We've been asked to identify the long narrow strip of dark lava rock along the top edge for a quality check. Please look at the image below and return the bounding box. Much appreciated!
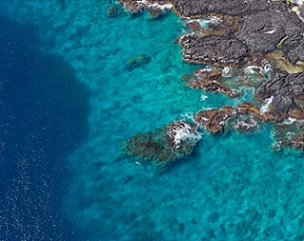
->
[170,0,269,17]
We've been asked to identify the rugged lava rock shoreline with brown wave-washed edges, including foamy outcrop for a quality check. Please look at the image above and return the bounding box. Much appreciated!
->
[120,0,304,166]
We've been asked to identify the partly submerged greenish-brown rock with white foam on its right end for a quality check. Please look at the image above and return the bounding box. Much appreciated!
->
[124,121,201,167]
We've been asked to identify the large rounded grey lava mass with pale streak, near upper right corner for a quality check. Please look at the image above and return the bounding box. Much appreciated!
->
[236,7,304,61]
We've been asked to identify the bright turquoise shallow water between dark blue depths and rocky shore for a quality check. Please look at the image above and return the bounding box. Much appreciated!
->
[0,0,304,241]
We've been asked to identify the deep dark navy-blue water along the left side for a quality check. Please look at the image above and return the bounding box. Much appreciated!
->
[0,16,90,240]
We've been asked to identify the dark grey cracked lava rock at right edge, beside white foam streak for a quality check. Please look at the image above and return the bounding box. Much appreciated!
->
[256,71,304,120]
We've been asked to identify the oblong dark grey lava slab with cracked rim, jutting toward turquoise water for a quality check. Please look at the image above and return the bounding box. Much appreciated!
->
[179,35,248,65]
